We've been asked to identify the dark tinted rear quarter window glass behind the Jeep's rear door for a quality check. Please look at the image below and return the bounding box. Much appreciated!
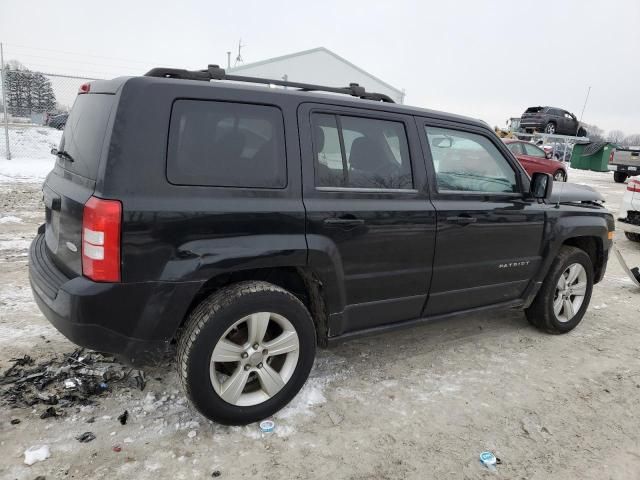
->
[167,100,287,188]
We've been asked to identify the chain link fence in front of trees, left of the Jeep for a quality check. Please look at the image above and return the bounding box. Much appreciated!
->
[0,62,102,161]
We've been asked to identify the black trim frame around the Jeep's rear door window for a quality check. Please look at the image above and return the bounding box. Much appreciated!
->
[309,108,419,194]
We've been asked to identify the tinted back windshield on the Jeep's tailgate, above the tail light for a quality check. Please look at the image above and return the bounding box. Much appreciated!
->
[58,93,115,180]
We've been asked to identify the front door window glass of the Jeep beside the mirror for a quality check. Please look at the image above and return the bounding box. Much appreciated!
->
[425,127,518,193]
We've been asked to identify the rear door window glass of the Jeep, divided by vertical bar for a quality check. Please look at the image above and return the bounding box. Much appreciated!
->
[311,113,413,189]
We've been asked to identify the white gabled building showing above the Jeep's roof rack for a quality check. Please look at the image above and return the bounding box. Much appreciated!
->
[227,47,405,103]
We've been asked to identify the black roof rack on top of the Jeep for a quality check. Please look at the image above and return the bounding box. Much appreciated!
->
[144,65,395,103]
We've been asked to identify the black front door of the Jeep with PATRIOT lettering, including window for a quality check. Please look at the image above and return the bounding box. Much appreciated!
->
[419,119,544,316]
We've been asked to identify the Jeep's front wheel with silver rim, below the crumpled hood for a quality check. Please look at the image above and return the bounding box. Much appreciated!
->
[525,245,593,334]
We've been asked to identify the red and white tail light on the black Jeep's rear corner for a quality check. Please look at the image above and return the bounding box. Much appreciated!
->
[82,197,122,282]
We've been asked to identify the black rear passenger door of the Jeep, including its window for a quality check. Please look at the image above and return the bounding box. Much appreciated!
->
[298,104,436,336]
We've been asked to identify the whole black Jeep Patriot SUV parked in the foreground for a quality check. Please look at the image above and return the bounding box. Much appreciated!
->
[30,66,614,424]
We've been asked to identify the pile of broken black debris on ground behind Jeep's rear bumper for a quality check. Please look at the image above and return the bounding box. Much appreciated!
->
[0,348,146,416]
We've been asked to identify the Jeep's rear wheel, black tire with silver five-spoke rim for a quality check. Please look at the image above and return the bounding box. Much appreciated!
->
[177,281,316,425]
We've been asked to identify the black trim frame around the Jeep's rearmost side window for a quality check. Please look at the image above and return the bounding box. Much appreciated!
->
[164,97,289,191]
